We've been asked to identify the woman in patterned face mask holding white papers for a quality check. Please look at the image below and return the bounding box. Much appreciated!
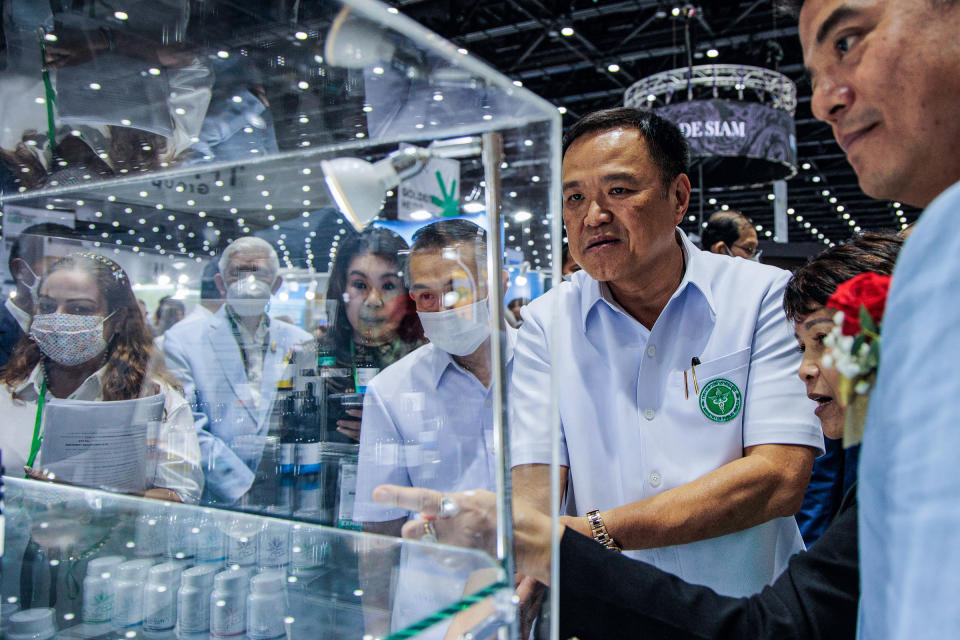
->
[0,253,203,503]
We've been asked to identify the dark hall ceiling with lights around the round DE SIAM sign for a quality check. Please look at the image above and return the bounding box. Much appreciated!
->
[393,0,918,242]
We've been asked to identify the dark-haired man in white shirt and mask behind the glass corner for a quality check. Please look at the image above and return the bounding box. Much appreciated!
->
[353,220,516,635]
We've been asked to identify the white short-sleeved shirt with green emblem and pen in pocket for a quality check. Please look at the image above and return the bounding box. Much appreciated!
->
[510,231,823,596]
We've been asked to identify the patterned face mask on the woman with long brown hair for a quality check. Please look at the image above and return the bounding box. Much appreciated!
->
[30,312,116,367]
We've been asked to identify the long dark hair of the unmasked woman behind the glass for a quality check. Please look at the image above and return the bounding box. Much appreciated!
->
[327,228,423,358]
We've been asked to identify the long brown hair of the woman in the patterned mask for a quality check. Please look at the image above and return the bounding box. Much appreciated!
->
[0,253,177,400]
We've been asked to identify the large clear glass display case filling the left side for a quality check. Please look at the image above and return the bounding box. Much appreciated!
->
[0,0,561,638]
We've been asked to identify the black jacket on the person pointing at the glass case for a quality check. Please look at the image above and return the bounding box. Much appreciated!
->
[559,485,860,640]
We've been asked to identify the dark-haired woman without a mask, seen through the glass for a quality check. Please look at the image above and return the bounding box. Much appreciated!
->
[321,229,424,442]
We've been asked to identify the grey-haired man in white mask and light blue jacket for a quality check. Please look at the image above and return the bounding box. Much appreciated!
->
[163,236,310,504]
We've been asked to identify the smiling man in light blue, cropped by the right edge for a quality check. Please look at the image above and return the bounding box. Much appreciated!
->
[796,0,960,640]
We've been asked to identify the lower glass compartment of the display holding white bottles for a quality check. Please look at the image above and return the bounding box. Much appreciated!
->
[0,478,510,640]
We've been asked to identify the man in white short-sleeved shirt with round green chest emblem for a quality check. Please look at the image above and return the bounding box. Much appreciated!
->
[510,109,823,595]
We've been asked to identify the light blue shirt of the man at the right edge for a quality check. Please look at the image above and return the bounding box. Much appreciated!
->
[859,183,960,640]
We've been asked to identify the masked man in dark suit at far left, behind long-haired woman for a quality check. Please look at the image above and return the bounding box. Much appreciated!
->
[0,223,81,367]
